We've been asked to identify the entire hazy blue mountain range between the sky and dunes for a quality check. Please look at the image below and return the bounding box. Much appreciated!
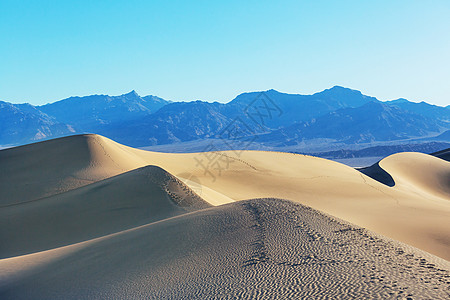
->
[0,86,450,149]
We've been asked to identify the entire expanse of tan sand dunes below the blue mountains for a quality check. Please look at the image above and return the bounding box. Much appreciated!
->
[0,135,450,299]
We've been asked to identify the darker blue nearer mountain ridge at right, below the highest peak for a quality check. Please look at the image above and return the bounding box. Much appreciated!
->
[256,102,446,144]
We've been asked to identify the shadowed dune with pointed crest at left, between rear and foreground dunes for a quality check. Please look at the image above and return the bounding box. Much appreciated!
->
[0,166,209,258]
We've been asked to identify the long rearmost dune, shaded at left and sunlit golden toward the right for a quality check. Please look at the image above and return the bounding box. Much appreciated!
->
[0,135,450,259]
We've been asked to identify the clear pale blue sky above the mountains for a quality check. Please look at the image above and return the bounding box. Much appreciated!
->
[0,0,450,105]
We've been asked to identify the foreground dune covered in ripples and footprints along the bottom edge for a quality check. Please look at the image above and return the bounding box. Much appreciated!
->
[0,199,450,299]
